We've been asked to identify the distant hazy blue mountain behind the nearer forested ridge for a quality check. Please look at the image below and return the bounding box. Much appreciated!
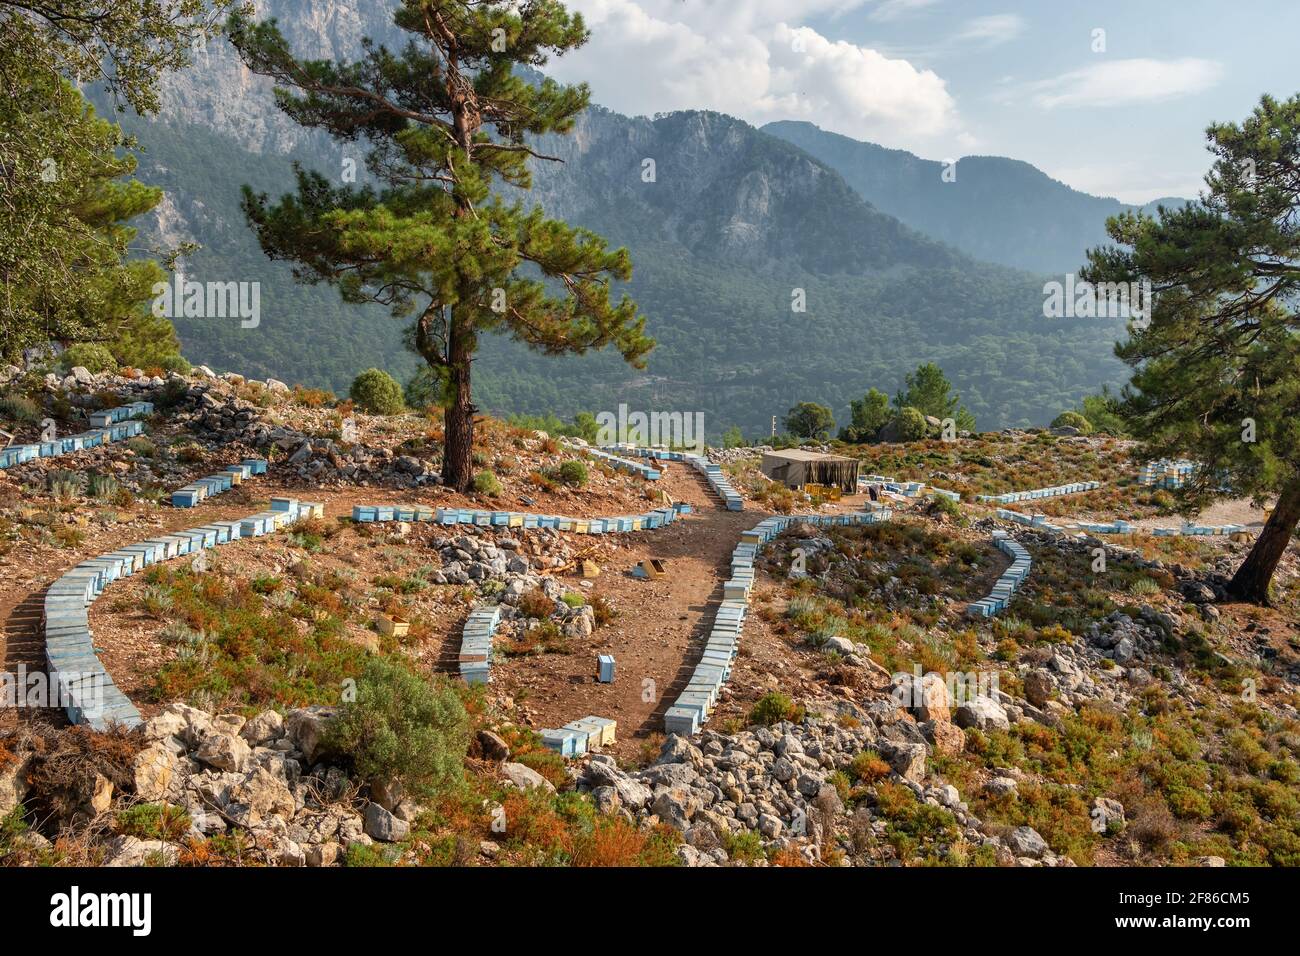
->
[762,121,1190,274]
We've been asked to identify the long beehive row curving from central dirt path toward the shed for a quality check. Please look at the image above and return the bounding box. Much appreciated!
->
[663,510,891,735]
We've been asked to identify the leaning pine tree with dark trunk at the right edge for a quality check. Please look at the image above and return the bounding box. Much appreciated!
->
[1084,96,1300,604]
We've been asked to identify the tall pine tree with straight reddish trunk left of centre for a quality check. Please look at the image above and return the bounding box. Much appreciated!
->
[229,0,654,490]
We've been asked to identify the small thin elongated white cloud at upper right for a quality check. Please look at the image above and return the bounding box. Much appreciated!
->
[1027,57,1223,109]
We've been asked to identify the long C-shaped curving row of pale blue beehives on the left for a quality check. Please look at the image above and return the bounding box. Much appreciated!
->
[43,498,324,730]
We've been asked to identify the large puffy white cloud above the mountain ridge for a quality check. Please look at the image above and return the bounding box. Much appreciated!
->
[545,0,961,150]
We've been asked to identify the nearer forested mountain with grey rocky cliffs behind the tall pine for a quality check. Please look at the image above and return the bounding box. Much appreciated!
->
[104,0,1123,436]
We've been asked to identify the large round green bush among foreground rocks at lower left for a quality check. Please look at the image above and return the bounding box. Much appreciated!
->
[324,657,469,797]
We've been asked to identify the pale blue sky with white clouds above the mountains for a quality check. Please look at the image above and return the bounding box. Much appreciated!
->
[547,0,1300,202]
